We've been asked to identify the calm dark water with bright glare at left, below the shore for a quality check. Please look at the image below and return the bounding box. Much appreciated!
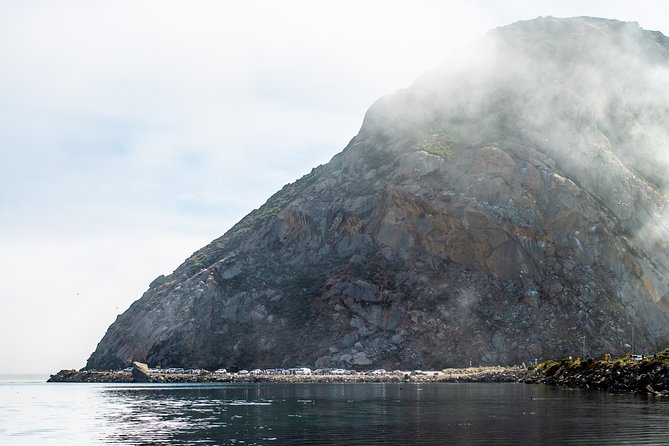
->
[0,381,669,446]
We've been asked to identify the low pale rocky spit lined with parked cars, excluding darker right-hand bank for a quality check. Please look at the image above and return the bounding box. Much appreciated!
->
[48,367,528,383]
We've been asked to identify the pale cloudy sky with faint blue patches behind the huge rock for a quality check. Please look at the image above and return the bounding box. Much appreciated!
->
[0,0,669,373]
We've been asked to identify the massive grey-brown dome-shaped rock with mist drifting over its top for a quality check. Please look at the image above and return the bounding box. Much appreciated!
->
[87,18,669,369]
